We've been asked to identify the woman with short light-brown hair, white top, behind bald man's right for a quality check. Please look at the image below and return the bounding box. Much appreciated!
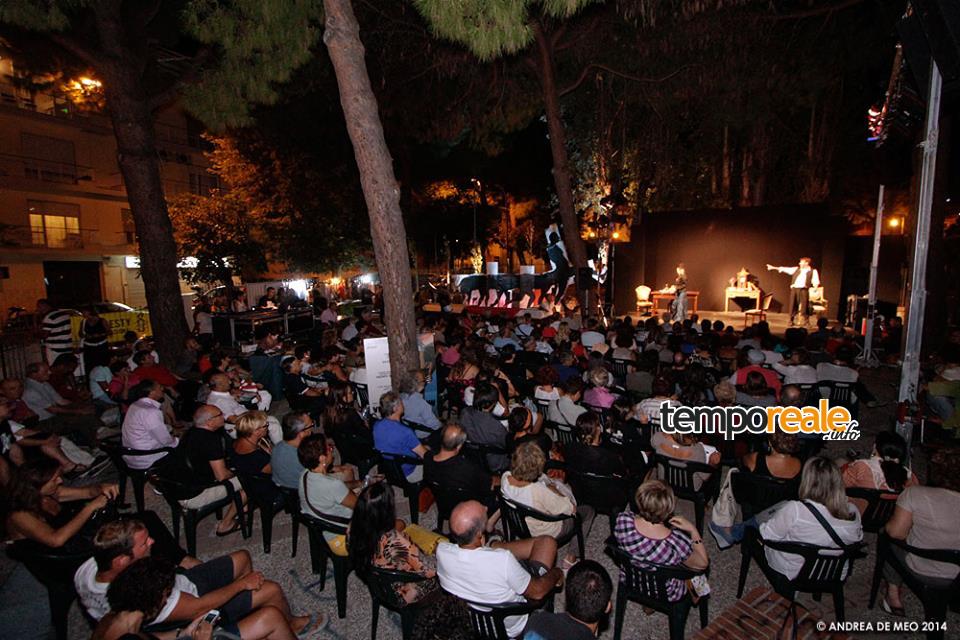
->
[500,442,594,538]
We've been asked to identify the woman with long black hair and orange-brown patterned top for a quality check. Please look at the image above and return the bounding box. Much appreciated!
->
[347,482,439,605]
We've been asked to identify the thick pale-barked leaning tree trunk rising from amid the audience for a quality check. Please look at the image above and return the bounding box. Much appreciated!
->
[323,0,420,382]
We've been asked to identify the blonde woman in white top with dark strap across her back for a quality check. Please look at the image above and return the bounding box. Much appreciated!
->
[757,456,863,580]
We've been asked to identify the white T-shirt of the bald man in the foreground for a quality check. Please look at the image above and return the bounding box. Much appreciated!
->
[437,542,532,638]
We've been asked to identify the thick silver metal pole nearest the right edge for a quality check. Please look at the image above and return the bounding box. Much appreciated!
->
[897,59,943,444]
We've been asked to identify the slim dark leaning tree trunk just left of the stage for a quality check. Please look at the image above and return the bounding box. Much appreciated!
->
[533,20,587,288]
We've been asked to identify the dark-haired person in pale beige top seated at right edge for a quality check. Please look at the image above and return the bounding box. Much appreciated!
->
[881,454,960,616]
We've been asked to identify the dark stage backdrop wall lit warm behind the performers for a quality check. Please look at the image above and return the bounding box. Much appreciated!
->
[614,205,847,318]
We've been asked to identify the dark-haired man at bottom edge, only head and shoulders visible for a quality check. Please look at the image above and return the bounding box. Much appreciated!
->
[523,560,613,640]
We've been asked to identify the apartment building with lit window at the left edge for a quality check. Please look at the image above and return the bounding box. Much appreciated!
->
[0,58,219,313]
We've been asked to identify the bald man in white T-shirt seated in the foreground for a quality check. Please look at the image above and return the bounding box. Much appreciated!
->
[437,500,563,638]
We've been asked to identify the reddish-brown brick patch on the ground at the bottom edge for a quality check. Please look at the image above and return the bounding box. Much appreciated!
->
[690,587,849,640]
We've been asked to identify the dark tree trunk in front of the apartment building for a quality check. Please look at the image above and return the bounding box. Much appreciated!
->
[96,7,190,364]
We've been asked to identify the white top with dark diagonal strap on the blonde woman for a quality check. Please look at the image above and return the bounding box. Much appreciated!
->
[760,500,863,580]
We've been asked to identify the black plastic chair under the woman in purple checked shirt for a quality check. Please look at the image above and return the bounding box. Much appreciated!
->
[607,540,710,640]
